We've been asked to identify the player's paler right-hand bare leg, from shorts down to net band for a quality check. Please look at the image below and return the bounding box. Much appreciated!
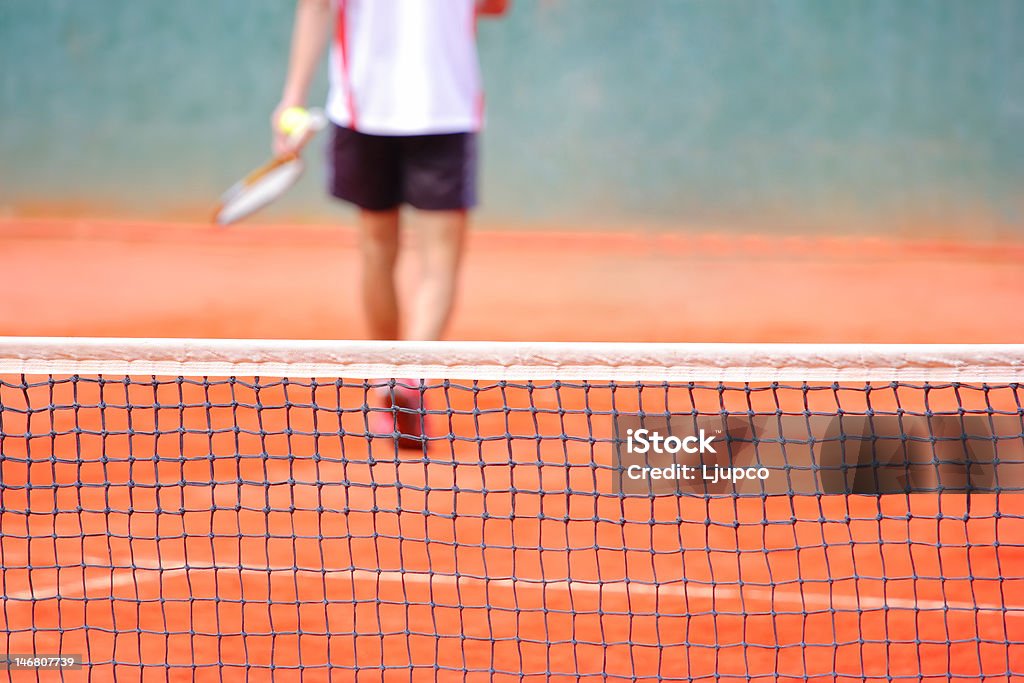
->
[408,211,469,340]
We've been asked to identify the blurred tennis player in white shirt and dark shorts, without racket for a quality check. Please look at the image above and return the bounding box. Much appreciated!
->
[272,0,508,445]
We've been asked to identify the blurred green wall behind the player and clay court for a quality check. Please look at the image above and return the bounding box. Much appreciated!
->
[0,0,1024,233]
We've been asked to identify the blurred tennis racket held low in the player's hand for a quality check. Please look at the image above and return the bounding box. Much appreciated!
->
[213,110,327,225]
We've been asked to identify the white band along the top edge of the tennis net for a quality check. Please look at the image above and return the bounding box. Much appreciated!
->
[0,337,1024,383]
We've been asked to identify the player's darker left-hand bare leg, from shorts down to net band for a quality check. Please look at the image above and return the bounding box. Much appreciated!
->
[359,209,398,339]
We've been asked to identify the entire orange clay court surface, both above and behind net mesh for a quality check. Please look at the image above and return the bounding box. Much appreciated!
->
[0,221,1024,682]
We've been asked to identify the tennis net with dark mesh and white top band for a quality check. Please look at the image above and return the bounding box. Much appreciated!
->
[0,338,1024,681]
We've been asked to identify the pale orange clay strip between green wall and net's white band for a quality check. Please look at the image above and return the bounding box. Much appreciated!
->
[6,219,1024,343]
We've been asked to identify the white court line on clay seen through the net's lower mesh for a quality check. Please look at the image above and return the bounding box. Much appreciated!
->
[6,557,1024,617]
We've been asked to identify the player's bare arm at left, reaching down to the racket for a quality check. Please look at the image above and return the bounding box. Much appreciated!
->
[270,0,333,154]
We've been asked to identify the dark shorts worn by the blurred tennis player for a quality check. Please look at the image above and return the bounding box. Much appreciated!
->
[328,125,476,211]
